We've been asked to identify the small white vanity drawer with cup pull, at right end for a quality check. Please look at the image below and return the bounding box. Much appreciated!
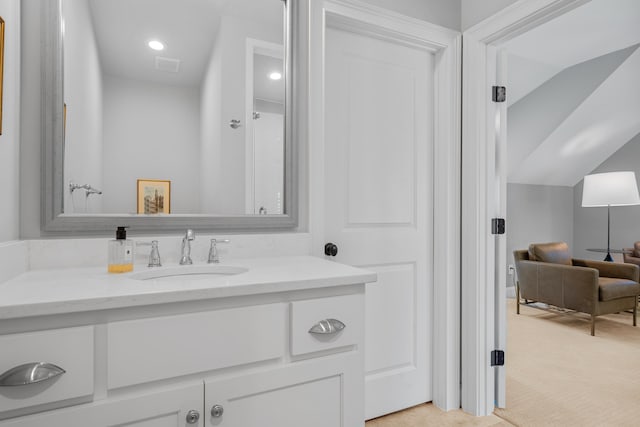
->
[291,295,364,356]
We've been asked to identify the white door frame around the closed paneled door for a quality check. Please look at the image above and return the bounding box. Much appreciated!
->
[306,0,462,411]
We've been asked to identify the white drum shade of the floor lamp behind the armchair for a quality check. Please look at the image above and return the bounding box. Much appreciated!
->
[582,172,640,207]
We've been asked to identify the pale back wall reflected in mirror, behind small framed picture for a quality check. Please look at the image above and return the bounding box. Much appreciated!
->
[102,75,201,214]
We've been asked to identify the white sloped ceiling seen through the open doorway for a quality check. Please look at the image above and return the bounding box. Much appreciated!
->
[505,0,640,186]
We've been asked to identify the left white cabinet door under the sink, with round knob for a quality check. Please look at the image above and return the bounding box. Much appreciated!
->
[0,383,204,427]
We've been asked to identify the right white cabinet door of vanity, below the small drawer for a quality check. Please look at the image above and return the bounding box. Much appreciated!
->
[204,353,364,427]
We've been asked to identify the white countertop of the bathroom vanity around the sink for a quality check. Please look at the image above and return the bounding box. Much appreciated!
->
[0,256,377,319]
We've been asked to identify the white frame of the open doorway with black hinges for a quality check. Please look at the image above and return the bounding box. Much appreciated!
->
[461,0,590,416]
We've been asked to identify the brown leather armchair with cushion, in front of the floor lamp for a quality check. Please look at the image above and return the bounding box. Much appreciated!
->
[513,242,640,335]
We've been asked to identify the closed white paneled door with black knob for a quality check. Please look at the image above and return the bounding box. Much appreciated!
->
[324,28,434,419]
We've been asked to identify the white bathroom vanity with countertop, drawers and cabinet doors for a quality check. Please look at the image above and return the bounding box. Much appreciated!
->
[0,256,376,427]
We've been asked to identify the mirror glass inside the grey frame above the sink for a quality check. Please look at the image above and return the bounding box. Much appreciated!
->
[62,0,285,216]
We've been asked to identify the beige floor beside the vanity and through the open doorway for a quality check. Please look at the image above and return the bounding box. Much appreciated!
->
[366,300,640,427]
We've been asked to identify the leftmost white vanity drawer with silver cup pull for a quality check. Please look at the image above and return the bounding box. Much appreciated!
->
[0,326,94,418]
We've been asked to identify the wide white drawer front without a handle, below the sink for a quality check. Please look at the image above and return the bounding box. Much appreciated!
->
[107,303,286,388]
